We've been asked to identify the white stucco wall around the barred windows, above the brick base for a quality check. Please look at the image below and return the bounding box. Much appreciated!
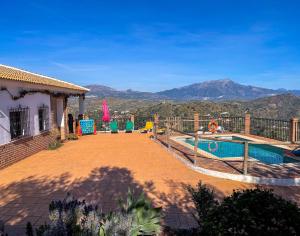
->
[0,83,51,145]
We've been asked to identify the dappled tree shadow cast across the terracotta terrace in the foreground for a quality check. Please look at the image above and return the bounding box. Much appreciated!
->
[0,166,222,235]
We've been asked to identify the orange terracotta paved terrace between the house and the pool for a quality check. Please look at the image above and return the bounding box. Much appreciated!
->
[0,133,300,235]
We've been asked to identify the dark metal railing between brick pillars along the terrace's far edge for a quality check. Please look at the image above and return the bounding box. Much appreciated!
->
[81,112,300,142]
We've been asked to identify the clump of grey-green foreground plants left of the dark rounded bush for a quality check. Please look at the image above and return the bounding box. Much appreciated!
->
[26,191,161,236]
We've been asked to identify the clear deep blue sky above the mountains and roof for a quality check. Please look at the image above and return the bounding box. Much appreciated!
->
[0,0,300,91]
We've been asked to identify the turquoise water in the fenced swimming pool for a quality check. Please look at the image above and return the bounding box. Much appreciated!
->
[185,136,297,164]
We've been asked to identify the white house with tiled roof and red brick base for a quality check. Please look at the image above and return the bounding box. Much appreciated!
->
[0,64,88,168]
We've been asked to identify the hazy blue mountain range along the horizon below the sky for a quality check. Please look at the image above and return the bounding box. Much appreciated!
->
[85,79,300,101]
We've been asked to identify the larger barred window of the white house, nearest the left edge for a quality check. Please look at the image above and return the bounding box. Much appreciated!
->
[9,106,30,139]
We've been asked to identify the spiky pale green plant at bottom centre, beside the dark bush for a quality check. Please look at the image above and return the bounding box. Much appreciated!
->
[100,190,161,236]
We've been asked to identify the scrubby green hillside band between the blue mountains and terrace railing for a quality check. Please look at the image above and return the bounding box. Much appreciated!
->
[69,94,300,120]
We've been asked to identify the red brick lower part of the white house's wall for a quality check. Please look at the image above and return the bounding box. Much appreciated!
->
[0,131,55,169]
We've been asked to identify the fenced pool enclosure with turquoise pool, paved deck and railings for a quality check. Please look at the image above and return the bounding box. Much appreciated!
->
[154,114,300,176]
